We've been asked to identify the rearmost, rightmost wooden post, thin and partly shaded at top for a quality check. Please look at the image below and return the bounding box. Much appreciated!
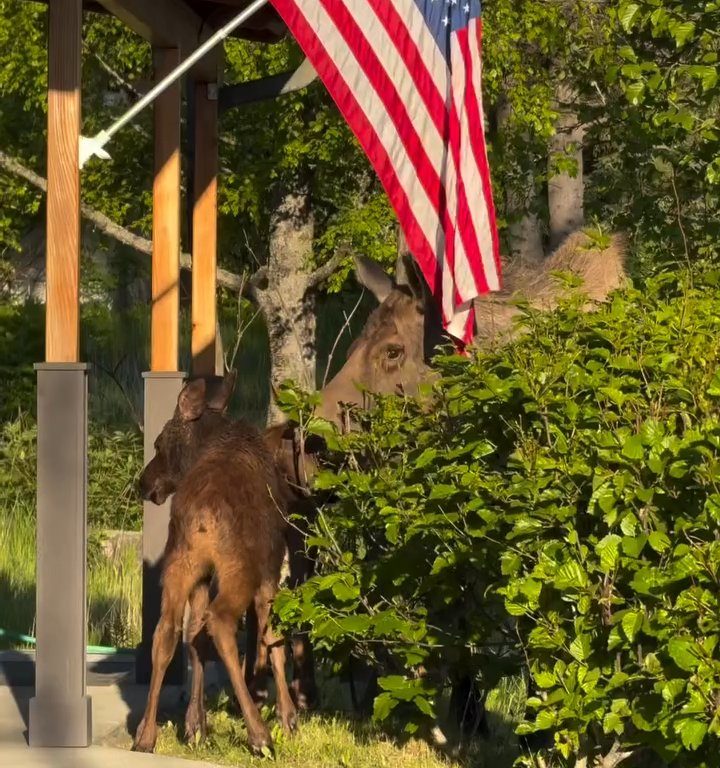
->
[192,83,218,376]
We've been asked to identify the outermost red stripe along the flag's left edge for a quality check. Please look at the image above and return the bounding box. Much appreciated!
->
[272,0,447,310]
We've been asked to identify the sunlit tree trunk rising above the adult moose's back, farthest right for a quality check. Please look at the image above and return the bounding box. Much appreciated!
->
[548,82,585,250]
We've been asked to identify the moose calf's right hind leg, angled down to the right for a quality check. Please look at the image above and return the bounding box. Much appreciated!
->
[205,571,272,754]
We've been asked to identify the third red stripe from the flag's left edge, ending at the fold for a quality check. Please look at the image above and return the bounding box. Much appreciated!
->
[367,0,449,137]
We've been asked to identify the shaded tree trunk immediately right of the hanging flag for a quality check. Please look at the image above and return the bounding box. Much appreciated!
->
[497,99,544,267]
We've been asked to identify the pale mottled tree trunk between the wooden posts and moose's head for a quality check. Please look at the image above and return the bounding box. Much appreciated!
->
[254,187,316,425]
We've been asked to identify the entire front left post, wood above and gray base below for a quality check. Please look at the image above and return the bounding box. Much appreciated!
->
[28,0,92,747]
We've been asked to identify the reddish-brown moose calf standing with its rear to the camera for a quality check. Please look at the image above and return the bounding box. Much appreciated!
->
[133,377,296,752]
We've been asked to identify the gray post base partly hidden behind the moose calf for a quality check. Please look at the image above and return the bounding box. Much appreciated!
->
[135,371,185,685]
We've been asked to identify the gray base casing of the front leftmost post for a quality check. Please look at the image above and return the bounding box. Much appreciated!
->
[29,363,92,747]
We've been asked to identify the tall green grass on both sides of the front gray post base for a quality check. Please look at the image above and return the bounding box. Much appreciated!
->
[0,501,142,648]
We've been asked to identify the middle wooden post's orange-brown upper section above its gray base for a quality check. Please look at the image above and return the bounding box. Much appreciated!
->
[150,48,180,371]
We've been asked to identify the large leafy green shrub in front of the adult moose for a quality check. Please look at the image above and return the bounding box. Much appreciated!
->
[276,275,720,766]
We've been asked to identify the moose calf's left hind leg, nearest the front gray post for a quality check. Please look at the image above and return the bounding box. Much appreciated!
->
[133,558,198,752]
